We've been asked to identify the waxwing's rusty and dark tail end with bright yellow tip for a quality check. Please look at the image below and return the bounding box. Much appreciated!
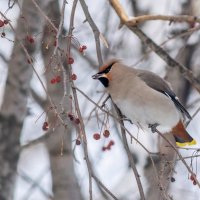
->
[172,121,196,147]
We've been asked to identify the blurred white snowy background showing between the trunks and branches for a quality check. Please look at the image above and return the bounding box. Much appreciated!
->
[0,0,200,200]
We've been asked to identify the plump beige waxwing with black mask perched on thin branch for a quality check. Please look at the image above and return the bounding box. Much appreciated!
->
[92,59,196,146]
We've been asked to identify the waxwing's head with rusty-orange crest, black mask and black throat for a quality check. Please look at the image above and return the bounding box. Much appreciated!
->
[92,59,120,87]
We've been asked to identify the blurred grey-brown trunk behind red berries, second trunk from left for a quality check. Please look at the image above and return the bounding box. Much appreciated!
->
[42,1,83,200]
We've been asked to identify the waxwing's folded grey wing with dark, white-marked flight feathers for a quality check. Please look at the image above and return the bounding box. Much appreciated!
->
[136,69,191,119]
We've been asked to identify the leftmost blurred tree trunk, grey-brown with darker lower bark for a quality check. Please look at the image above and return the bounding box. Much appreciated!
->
[0,0,52,200]
